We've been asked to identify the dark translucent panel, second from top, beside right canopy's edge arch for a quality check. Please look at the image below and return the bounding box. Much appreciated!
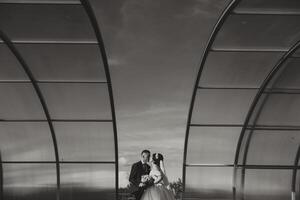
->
[213,15,300,50]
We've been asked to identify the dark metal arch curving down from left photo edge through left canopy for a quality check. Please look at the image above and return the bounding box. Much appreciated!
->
[0,30,60,200]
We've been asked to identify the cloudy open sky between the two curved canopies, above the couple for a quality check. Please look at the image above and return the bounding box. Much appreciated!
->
[92,0,228,187]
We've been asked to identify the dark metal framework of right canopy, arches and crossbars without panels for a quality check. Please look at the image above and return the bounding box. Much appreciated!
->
[183,0,300,199]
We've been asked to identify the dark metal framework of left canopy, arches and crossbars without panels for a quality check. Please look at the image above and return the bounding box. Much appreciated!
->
[0,0,119,200]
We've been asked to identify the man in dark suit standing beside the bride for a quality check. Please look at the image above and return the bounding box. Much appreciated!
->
[129,150,150,200]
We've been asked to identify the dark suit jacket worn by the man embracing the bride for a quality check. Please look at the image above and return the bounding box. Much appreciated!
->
[129,161,151,199]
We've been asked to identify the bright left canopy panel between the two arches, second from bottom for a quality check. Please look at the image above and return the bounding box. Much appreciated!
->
[54,122,115,161]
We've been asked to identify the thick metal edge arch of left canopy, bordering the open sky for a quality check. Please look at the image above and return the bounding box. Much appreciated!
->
[80,0,119,199]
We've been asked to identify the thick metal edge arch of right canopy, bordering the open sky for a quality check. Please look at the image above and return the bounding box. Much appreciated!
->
[182,0,240,192]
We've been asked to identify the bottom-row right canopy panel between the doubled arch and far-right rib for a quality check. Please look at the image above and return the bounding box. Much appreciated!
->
[244,169,292,200]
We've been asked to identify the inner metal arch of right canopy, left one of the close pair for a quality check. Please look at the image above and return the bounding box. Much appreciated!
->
[233,41,300,199]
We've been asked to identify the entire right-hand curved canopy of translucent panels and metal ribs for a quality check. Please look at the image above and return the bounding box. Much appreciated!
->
[183,0,300,200]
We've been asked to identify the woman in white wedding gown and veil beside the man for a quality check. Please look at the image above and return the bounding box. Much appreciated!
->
[141,153,175,200]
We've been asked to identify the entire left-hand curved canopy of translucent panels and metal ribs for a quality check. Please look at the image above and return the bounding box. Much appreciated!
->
[0,0,118,200]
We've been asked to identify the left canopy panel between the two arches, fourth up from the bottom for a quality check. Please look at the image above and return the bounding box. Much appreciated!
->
[16,44,106,81]
